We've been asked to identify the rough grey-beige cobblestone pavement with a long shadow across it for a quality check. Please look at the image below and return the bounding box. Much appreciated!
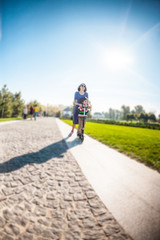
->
[0,118,131,240]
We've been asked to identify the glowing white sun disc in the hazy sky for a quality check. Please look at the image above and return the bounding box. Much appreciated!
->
[104,48,134,70]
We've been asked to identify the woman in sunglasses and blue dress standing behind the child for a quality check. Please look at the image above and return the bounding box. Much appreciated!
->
[69,83,88,137]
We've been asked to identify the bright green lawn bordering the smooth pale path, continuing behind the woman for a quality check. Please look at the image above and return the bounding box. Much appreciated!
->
[63,120,160,171]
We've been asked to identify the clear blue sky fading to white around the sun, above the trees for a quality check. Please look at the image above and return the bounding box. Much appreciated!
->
[0,0,160,114]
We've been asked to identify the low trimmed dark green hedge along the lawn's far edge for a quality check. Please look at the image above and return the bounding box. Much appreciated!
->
[87,118,160,130]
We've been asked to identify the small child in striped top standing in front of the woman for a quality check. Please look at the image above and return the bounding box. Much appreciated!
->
[77,97,90,136]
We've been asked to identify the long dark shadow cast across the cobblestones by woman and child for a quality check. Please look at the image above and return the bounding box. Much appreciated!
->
[0,137,81,173]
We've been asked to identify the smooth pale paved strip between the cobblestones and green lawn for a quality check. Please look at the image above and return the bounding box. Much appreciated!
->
[57,120,160,240]
